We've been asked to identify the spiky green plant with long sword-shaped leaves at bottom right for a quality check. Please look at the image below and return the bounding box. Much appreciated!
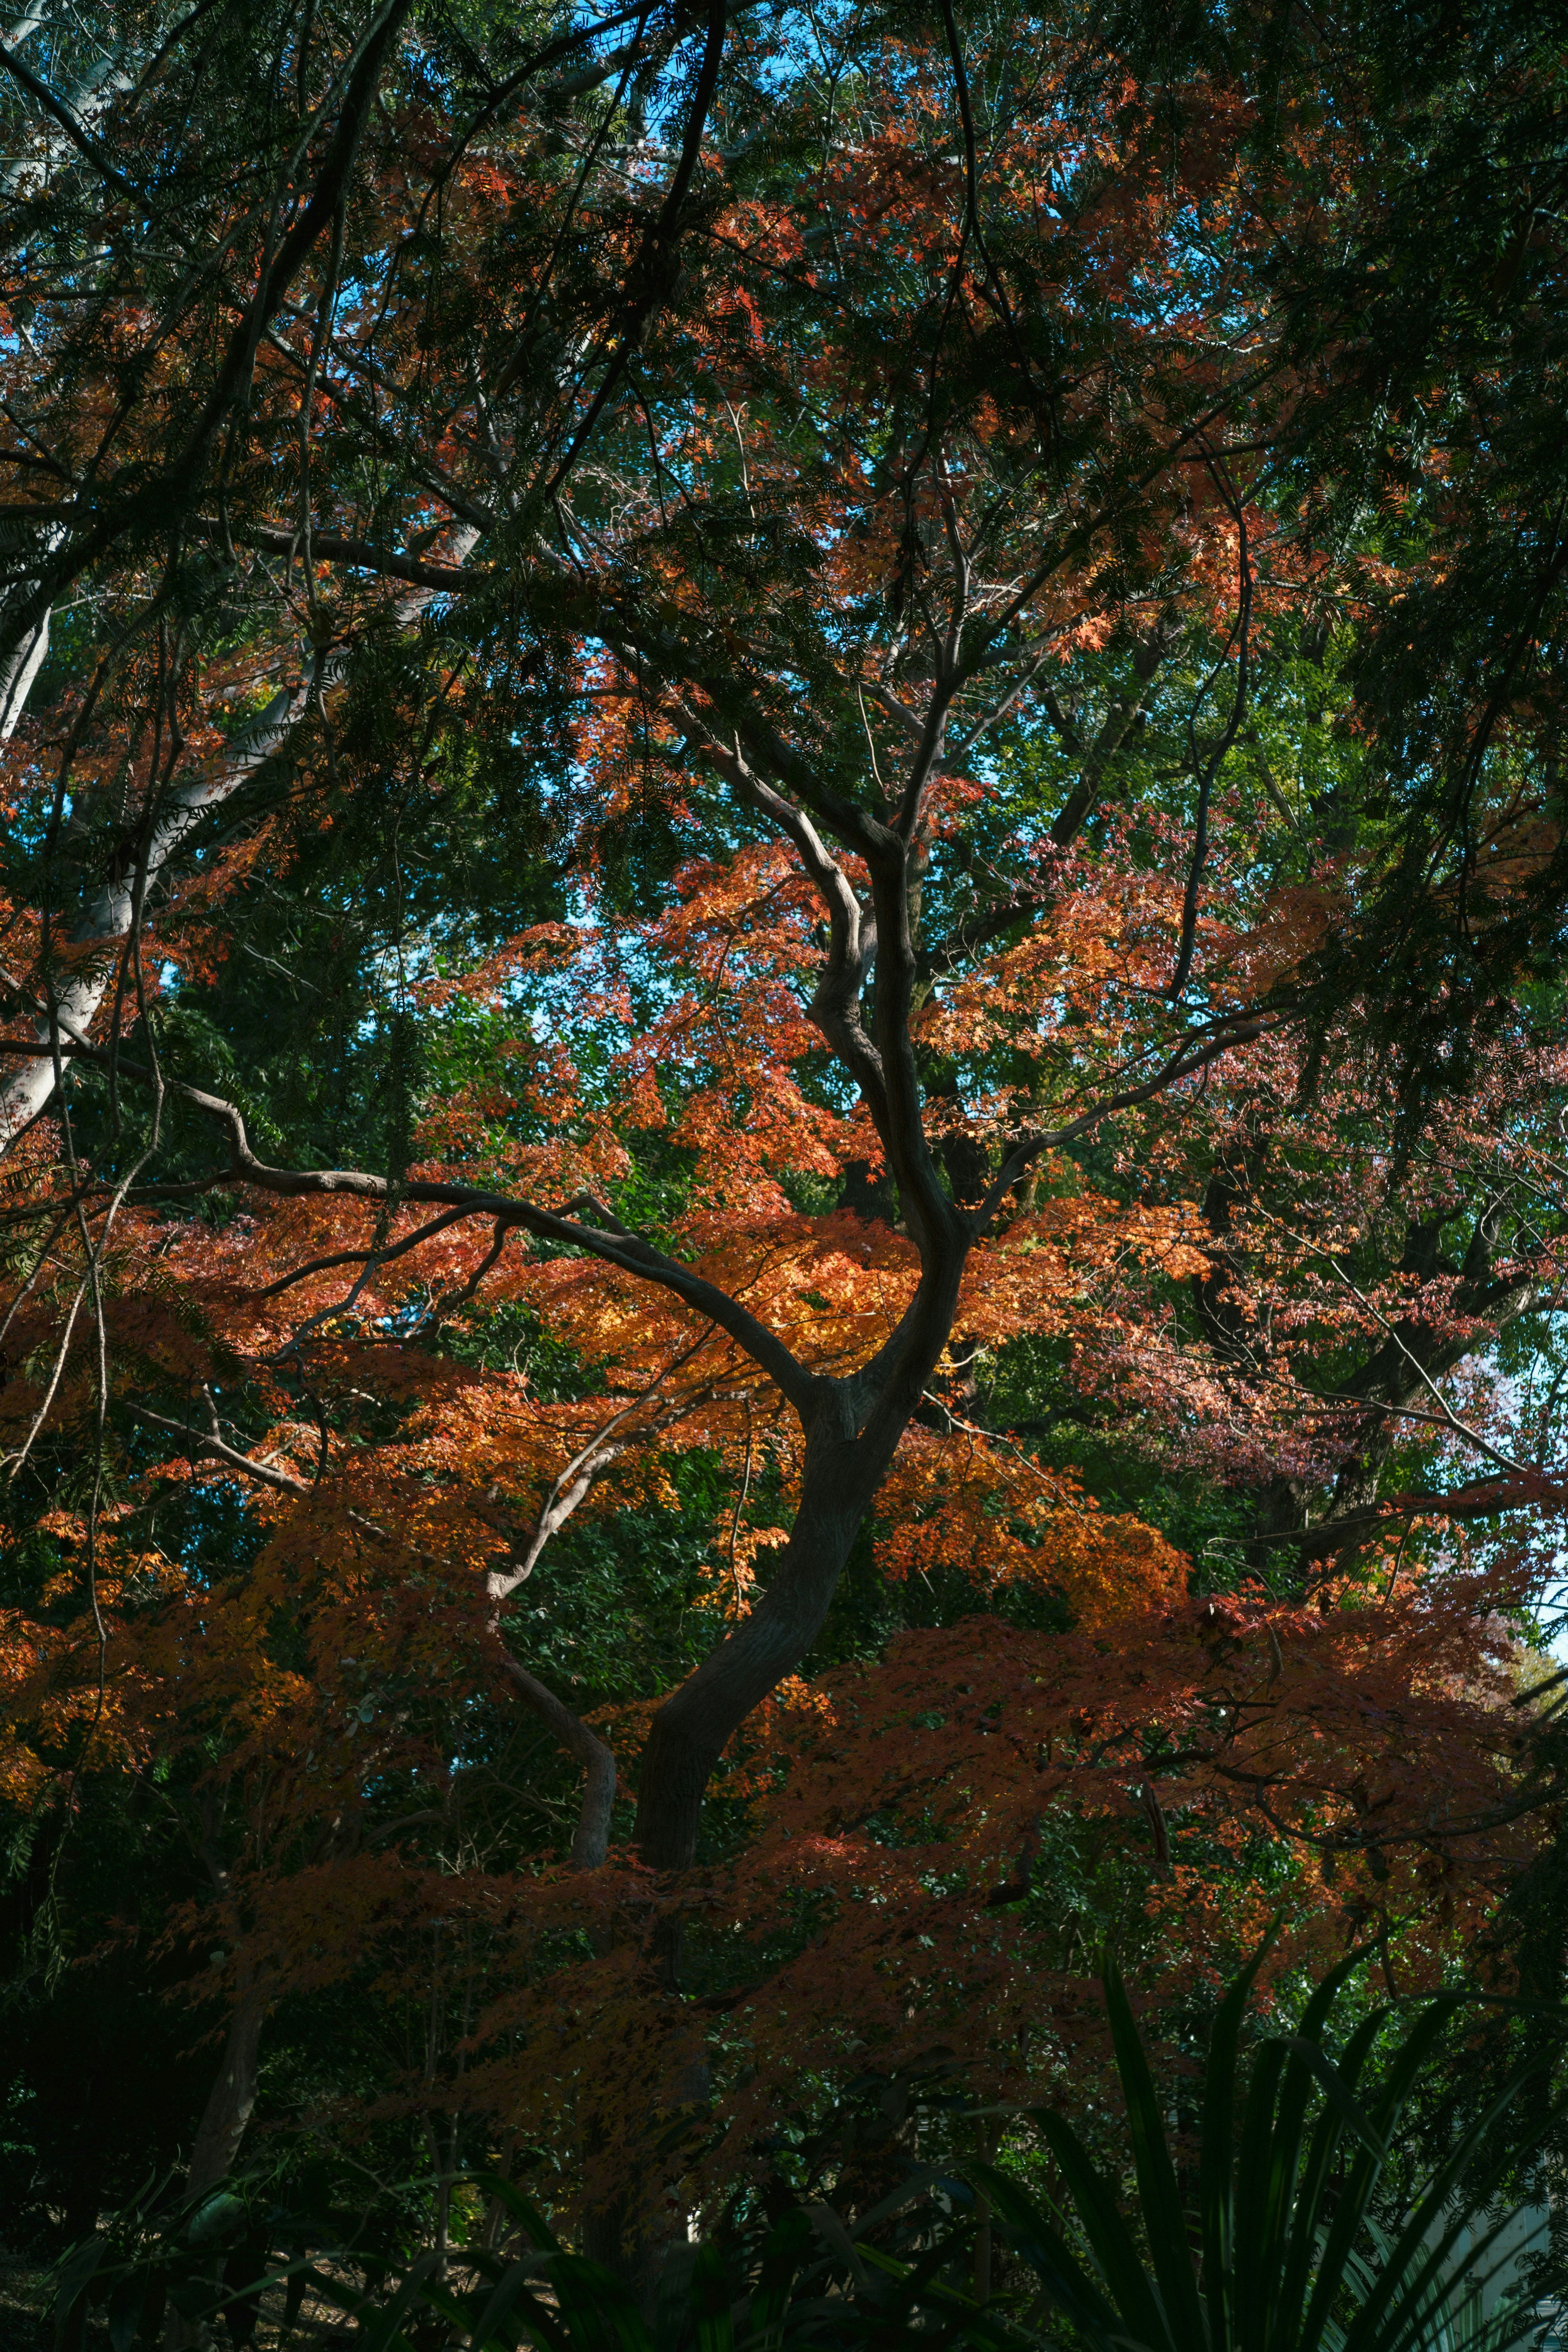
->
[959,1952,1568,2352]
